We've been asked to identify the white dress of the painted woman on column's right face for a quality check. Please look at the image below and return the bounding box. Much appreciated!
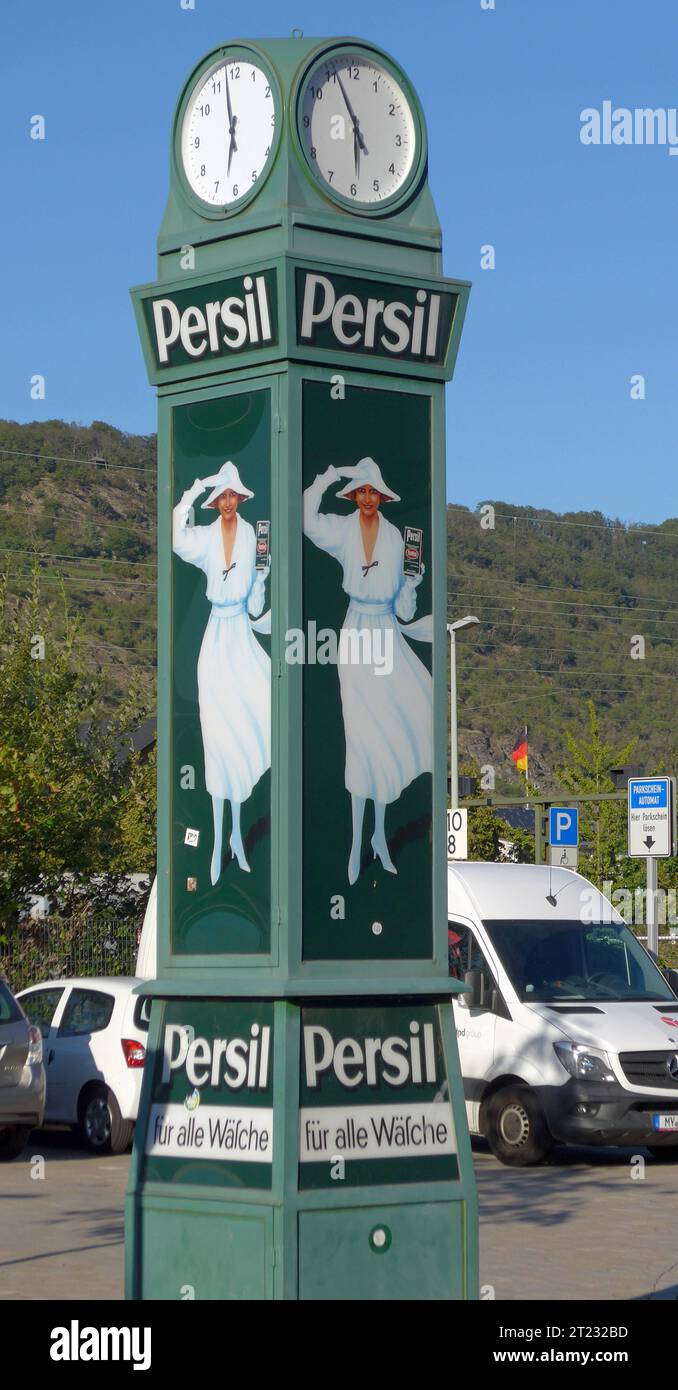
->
[304,468,433,803]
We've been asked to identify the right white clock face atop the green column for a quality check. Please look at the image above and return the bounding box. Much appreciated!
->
[299,51,417,206]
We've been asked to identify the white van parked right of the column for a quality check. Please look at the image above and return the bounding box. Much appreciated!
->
[447,863,678,1165]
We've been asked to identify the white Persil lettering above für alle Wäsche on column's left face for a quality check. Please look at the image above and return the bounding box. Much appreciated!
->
[163,1023,271,1091]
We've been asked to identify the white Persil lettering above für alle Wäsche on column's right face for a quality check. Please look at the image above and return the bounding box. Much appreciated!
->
[304,1019,438,1090]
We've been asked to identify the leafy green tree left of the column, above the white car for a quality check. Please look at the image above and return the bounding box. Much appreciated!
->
[0,569,153,931]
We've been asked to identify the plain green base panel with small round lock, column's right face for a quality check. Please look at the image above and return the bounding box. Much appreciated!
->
[299,1202,465,1302]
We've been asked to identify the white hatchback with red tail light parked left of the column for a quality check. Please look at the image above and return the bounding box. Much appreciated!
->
[17,976,149,1154]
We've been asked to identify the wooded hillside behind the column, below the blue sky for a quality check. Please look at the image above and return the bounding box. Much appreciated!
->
[0,420,678,792]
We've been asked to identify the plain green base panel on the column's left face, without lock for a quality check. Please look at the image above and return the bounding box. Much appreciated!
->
[139,1198,272,1301]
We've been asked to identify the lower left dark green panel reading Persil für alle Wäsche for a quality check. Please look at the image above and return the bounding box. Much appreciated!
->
[139,999,274,1190]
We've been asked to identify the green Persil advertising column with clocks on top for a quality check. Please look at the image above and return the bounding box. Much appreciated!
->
[126,39,478,1300]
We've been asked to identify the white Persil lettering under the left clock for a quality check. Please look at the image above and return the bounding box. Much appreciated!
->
[151,274,275,367]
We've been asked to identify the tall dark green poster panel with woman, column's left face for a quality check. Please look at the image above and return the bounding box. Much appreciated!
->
[172,389,271,955]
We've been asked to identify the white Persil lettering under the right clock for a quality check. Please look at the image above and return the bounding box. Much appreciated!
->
[297,271,452,363]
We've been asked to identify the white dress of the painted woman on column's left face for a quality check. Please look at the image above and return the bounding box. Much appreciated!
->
[172,489,271,802]
